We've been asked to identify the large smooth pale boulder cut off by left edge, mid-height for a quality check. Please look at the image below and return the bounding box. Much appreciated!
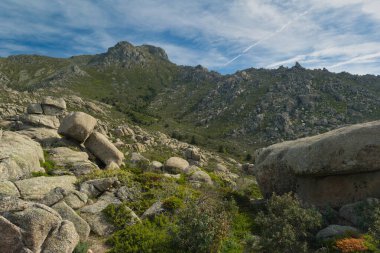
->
[0,130,44,180]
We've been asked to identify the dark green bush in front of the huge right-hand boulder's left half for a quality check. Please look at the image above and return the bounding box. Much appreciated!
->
[255,194,322,253]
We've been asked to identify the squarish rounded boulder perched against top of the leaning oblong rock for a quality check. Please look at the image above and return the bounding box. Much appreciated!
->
[58,112,97,143]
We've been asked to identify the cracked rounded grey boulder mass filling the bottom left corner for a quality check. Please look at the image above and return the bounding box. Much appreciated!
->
[0,204,79,253]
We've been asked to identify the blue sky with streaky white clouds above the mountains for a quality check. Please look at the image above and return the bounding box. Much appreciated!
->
[0,0,380,75]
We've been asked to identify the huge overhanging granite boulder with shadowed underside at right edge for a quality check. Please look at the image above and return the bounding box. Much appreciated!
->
[254,121,380,207]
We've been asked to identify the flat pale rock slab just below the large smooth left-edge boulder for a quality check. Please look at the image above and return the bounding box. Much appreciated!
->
[15,176,77,200]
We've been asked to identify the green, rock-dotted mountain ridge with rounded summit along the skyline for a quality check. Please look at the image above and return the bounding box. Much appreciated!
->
[0,42,380,156]
